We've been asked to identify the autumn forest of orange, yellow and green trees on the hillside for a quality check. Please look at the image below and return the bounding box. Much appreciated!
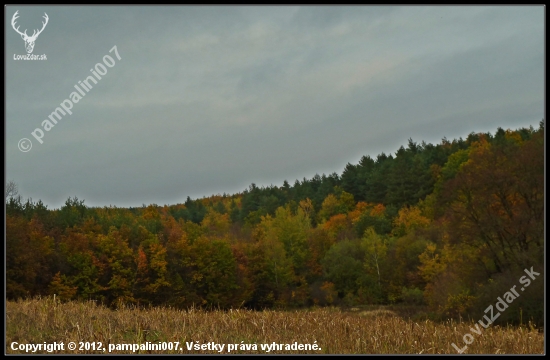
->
[6,121,544,323]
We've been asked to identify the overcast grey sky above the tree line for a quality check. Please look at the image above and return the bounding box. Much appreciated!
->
[4,6,545,209]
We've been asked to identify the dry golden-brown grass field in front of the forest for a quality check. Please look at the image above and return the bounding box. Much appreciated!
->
[6,298,544,354]
